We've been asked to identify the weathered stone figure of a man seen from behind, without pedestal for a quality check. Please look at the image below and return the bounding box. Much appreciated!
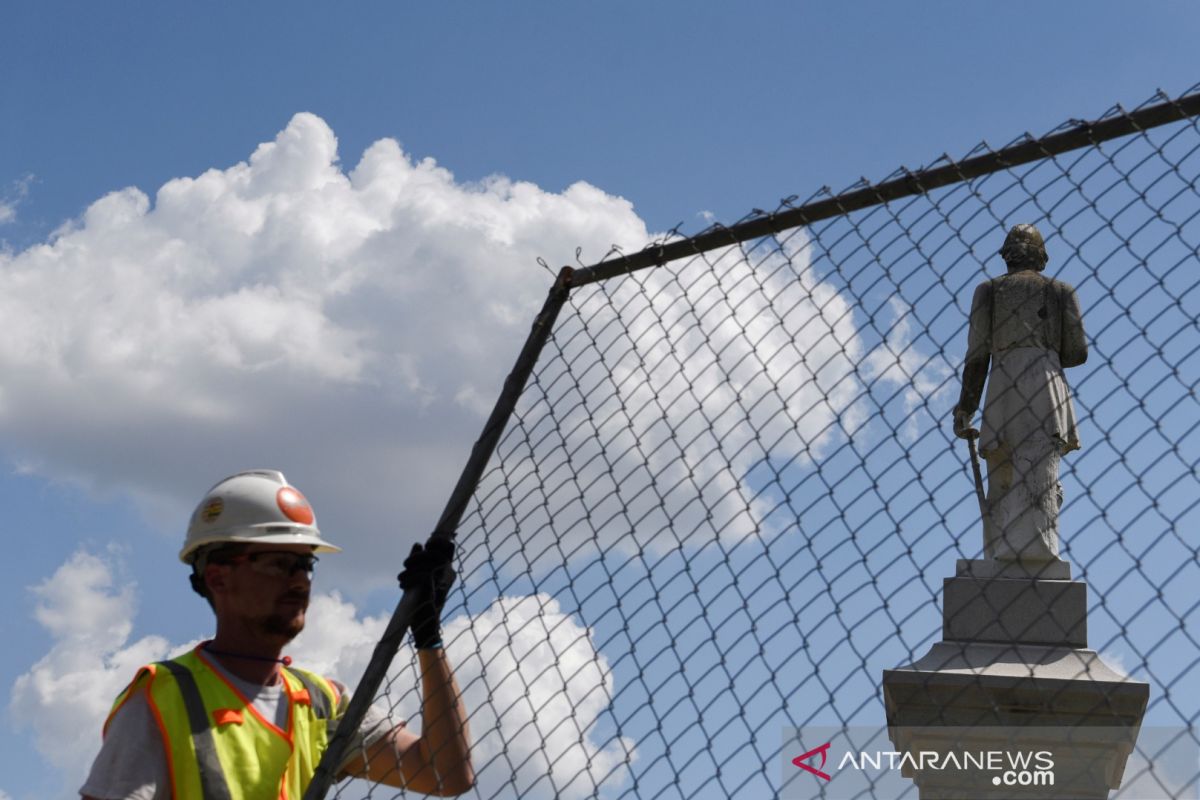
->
[954,224,1087,563]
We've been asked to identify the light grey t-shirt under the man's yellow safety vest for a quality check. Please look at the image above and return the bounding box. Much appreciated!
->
[79,664,401,800]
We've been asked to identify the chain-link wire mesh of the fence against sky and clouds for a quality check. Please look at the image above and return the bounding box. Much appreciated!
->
[338,86,1200,798]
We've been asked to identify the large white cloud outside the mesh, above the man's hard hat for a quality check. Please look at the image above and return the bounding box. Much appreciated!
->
[0,114,648,583]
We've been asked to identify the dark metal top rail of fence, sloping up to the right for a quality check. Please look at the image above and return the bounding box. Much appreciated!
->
[571,81,1200,287]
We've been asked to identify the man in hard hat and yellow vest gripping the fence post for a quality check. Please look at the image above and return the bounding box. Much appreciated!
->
[80,470,474,800]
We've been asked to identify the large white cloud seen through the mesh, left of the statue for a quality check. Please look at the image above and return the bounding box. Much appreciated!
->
[464,231,948,575]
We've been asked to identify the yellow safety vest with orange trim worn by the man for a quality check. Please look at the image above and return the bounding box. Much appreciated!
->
[104,644,338,800]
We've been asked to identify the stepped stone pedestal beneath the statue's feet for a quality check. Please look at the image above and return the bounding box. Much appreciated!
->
[883,561,1150,800]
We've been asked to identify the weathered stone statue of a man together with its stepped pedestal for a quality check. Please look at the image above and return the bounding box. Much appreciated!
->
[882,225,1150,800]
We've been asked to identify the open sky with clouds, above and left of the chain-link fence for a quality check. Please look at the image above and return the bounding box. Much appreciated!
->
[0,1,1200,800]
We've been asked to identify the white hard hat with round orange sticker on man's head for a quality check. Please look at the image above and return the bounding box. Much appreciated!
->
[179,469,342,564]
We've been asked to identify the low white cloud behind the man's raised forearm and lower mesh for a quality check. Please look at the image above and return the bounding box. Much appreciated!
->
[290,594,636,800]
